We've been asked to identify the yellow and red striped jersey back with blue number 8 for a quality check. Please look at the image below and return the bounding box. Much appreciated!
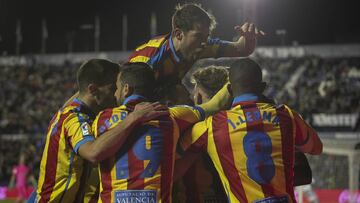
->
[207,102,295,202]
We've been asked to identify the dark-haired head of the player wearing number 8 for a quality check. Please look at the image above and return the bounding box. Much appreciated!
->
[229,58,265,95]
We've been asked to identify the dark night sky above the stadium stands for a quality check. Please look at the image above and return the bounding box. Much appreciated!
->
[0,0,360,55]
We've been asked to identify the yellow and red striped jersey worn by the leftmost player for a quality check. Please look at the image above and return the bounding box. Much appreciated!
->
[36,99,95,203]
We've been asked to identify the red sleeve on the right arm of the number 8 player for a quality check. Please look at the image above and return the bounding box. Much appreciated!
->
[292,111,322,154]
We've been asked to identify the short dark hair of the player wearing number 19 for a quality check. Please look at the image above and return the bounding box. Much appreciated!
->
[120,62,155,99]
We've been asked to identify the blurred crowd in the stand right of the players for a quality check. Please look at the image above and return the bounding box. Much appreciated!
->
[259,57,360,118]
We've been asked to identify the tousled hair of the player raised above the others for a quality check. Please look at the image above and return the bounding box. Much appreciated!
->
[172,3,216,32]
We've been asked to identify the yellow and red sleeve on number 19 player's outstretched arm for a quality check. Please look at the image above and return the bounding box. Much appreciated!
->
[170,105,205,132]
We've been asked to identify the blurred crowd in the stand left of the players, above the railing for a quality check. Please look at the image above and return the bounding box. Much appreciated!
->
[0,61,77,134]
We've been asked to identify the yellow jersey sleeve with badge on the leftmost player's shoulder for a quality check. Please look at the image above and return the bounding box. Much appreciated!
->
[64,113,94,154]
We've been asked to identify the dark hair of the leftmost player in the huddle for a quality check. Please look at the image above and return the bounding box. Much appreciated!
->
[76,59,120,94]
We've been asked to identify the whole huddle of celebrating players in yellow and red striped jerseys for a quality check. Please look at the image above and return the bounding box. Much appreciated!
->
[28,3,322,203]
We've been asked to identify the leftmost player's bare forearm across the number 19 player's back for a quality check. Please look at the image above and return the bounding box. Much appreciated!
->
[90,114,140,163]
